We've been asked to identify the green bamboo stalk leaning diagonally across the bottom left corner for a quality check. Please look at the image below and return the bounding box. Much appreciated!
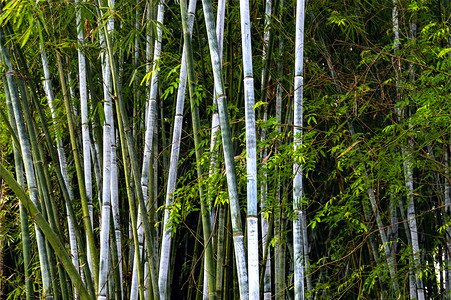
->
[0,163,94,300]
